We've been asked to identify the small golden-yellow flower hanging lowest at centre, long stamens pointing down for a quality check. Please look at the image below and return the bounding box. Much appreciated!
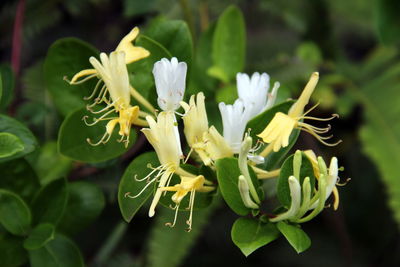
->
[156,175,215,231]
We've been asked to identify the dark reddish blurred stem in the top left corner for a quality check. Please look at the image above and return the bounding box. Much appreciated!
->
[11,0,25,76]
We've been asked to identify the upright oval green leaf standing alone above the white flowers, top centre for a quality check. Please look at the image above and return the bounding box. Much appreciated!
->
[209,6,246,82]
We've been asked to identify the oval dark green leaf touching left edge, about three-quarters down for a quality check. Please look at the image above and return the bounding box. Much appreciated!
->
[0,189,32,235]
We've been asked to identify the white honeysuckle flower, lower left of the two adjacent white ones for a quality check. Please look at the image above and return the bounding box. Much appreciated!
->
[219,99,252,153]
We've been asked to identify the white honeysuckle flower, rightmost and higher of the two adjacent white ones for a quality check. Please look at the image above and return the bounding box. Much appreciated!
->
[236,72,279,118]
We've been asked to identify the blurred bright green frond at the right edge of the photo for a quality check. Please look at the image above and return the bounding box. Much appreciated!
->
[352,63,400,225]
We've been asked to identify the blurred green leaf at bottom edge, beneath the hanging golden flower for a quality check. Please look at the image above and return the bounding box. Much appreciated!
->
[146,196,221,267]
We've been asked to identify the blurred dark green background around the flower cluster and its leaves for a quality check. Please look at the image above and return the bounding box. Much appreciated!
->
[0,0,400,267]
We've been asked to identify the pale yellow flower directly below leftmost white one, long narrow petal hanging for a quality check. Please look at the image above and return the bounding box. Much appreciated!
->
[141,112,180,217]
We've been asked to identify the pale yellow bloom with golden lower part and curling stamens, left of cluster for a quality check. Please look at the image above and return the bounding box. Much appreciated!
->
[83,52,147,146]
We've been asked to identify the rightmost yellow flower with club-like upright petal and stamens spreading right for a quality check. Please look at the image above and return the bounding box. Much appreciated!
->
[258,72,341,156]
